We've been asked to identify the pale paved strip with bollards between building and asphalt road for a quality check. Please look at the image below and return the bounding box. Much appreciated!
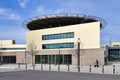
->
[0,63,120,75]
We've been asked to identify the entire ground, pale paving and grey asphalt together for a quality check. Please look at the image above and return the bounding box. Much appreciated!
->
[0,64,120,80]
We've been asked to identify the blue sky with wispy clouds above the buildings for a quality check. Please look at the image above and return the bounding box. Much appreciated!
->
[0,0,120,44]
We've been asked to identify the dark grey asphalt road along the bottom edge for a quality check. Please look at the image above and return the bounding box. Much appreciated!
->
[0,71,120,80]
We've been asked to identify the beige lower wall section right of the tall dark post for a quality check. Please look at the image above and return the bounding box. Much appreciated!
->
[80,48,105,65]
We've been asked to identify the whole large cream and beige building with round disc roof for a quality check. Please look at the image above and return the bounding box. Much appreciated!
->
[25,14,105,65]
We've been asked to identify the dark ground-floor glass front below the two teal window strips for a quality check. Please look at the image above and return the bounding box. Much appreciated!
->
[35,54,72,64]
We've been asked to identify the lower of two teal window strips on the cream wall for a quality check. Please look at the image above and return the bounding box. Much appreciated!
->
[42,42,74,49]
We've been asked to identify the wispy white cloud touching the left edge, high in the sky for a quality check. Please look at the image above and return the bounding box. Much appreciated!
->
[0,8,21,20]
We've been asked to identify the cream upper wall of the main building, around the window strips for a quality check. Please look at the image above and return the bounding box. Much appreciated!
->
[27,22,100,50]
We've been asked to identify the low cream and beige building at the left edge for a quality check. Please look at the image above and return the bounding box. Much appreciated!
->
[0,40,26,63]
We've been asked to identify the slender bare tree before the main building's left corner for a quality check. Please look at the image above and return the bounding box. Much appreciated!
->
[27,41,38,67]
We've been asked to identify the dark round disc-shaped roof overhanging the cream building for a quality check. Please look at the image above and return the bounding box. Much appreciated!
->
[24,14,106,30]
